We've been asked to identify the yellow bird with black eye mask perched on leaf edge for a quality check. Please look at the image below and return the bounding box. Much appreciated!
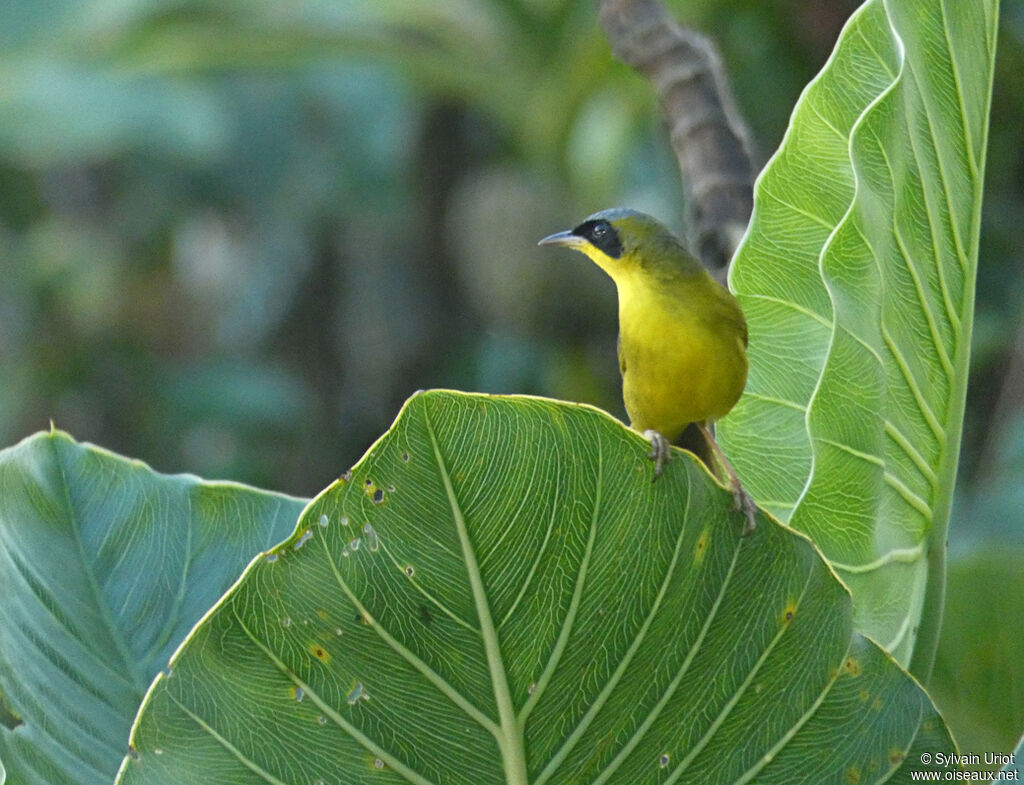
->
[539,208,755,532]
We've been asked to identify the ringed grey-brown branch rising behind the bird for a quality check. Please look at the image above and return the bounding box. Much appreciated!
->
[599,0,756,280]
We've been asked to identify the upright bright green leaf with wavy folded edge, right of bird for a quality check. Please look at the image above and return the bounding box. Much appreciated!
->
[721,0,997,679]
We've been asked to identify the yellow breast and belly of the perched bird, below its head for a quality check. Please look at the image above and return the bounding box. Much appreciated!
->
[615,275,746,441]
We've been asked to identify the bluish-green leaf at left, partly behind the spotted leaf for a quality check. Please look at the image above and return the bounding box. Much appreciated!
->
[0,432,304,785]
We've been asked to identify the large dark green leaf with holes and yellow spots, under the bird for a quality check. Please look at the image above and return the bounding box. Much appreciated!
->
[119,392,951,785]
